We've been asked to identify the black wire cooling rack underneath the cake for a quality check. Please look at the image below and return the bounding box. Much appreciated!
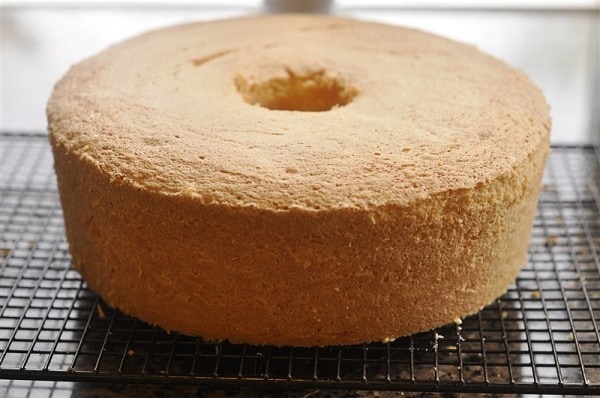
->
[0,133,600,394]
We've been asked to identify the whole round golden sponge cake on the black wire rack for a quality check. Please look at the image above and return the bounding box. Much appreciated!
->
[48,15,550,346]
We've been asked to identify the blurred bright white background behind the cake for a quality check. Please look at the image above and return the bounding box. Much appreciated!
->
[0,0,600,144]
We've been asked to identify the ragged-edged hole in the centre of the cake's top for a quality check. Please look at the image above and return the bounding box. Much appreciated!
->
[235,70,358,112]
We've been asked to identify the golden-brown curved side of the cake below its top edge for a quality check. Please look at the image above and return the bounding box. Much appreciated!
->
[53,127,548,346]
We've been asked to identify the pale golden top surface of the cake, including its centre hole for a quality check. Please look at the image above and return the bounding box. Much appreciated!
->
[47,15,550,211]
